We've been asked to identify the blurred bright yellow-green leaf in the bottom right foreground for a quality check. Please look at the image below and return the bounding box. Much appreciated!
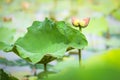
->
[45,49,120,80]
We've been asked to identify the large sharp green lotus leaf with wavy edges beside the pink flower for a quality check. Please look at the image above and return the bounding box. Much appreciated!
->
[12,18,87,63]
